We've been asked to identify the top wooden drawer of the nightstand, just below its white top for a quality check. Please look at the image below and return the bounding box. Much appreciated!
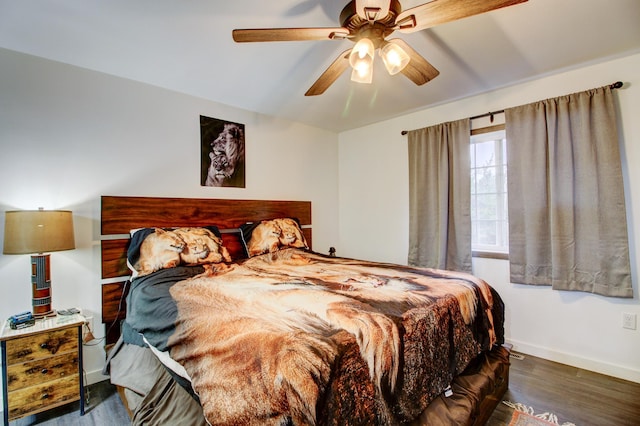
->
[7,328,78,365]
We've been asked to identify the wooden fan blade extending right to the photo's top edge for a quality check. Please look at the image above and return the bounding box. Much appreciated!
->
[396,0,527,33]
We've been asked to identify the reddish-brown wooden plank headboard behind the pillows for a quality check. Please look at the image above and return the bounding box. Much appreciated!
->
[101,196,312,343]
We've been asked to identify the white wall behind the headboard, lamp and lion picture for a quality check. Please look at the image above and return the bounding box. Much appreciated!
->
[0,49,338,402]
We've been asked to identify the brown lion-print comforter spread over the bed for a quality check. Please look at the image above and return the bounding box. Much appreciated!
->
[124,248,504,425]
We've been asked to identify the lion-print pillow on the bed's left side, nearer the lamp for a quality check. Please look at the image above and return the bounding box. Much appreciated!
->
[127,226,231,276]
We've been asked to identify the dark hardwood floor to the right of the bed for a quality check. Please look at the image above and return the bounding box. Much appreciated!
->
[487,355,640,426]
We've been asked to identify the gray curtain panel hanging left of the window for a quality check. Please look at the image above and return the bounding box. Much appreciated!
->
[407,119,471,272]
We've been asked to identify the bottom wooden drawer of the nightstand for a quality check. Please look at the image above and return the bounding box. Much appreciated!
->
[8,373,80,418]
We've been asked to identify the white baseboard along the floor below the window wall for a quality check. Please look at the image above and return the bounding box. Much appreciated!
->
[509,339,640,383]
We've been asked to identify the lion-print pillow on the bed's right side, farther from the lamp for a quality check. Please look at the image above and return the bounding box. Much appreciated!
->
[240,218,309,257]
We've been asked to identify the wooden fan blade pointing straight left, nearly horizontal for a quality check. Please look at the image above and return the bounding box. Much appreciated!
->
[232,28,349,43]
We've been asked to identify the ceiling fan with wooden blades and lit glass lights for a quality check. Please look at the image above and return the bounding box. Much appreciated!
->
[233,0,527,96]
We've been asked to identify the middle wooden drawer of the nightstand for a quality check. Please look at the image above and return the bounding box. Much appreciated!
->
[7,352,78,392]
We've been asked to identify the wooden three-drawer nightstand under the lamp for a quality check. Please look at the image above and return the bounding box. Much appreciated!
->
[0,314,85,426]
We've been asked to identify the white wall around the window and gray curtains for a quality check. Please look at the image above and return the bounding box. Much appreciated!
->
[337,54,640,382]
